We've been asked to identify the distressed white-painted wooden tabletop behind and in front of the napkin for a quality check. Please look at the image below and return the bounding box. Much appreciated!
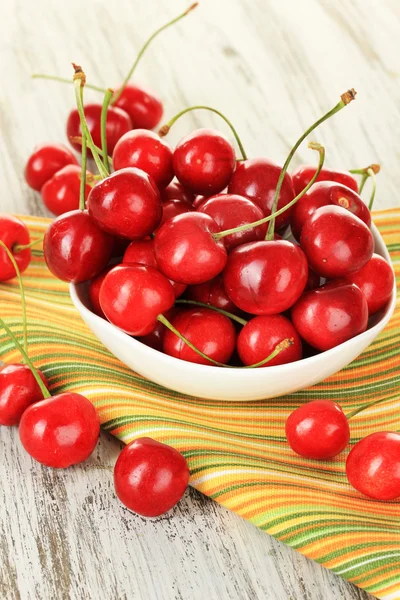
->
[0,0,400,600]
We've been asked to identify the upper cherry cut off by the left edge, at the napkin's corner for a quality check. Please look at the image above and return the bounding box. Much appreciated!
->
[0,213,31,281]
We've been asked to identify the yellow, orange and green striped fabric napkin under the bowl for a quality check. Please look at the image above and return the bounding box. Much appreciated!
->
[0,210,400,600]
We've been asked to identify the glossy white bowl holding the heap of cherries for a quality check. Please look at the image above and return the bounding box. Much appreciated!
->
[70,225,396,401]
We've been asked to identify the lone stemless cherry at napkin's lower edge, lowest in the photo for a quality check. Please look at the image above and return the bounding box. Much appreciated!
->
[114,438,190,517]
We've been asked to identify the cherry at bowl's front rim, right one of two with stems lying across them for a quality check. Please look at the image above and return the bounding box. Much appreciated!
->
[237,315,302,368]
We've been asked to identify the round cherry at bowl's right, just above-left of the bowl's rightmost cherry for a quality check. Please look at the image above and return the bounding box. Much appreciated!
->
[300,206,374,279]
